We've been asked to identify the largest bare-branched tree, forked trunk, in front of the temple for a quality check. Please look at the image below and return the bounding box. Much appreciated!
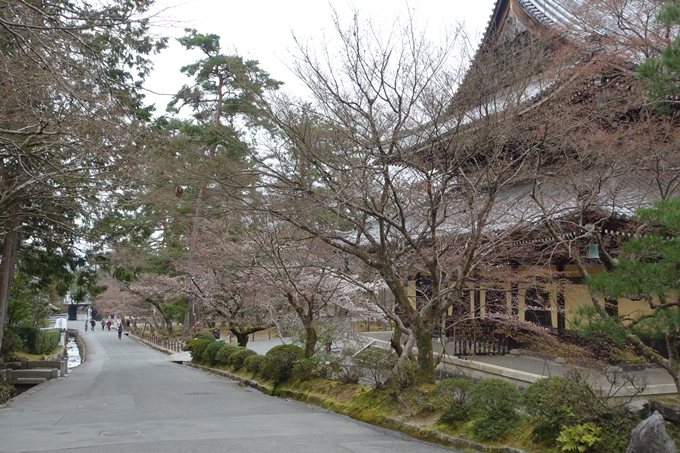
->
[244,12,543,382]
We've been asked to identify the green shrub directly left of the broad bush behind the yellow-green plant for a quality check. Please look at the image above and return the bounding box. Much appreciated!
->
[470,379,520,440]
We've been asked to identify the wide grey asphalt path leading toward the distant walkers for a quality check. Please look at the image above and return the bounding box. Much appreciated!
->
[0,329,464,453]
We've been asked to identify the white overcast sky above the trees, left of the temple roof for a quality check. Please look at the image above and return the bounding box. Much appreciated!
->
[145,0,495,114]
